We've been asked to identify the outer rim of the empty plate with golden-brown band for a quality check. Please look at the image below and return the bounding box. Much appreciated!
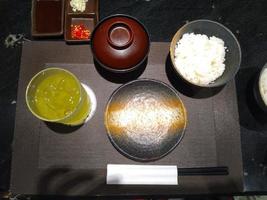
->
[104,78,188,162]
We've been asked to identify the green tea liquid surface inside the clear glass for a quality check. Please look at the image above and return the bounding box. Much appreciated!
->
[33,72,80,120]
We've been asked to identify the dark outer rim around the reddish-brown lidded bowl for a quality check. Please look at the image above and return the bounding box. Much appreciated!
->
[90,14,151,73]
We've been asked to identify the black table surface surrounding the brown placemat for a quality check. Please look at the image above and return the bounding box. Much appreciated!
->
[0,0,267,193]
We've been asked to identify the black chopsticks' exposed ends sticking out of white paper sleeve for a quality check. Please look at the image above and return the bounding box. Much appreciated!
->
[178,166,229,176]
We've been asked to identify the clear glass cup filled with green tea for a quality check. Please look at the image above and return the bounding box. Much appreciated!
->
[28,68,90,125]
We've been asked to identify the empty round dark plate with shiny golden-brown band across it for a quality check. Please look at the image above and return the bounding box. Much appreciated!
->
[105,79,187,161]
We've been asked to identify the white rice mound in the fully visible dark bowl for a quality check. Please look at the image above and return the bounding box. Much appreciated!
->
[174,33,226,85]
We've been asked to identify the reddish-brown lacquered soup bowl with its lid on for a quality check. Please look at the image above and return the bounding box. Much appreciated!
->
[91,15,150,73]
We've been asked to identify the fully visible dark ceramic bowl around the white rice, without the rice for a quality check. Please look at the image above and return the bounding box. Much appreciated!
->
[170,19,241,87]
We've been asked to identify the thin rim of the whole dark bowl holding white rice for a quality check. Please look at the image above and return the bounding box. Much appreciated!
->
[172,19,242,88]
